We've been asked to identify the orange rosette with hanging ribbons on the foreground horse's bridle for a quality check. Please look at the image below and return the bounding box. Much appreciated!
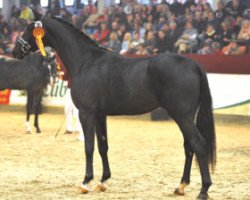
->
[33,21,46,57]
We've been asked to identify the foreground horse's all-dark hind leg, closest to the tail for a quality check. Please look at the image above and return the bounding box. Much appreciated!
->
[176,117,212,200]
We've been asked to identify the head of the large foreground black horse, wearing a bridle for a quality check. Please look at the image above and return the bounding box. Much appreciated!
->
[12,10,47,59]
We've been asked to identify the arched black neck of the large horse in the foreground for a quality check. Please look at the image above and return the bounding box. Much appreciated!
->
[43,18,98,77]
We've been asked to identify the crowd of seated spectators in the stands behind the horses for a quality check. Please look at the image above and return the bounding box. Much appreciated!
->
[0,0,250,55]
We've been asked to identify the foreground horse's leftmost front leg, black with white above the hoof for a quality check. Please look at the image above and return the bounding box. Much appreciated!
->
[79,110,95,194]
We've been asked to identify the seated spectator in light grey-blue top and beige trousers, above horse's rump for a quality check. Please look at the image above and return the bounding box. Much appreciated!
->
[175,22,198,53]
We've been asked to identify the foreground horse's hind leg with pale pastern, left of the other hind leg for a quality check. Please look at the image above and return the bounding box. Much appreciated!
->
[174,138,194,195]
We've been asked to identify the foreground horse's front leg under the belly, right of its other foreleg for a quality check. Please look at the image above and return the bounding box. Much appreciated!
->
[95,116,111,192]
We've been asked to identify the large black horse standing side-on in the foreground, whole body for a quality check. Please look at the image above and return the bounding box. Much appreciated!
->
[13,12,216,199]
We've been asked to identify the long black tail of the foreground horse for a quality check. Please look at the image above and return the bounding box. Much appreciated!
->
[196,67,216,170]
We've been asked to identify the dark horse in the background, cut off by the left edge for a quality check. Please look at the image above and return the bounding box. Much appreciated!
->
[0,52,57,133]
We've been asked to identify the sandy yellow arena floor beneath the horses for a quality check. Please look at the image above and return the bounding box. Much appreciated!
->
[0,108,250,200]
